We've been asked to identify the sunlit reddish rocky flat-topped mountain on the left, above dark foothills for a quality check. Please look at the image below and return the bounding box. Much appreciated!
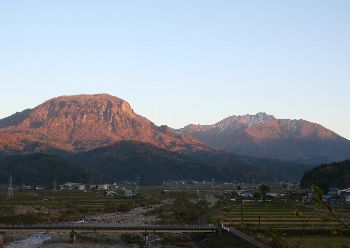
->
[0,94,211,154]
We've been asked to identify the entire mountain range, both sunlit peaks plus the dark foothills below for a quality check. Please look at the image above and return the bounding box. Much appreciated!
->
[0,94,350,184]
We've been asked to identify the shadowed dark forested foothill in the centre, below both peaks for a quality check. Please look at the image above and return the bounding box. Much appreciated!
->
[70,141,307,184]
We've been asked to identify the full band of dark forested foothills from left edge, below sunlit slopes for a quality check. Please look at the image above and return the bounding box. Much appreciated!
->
[0,141,309,185]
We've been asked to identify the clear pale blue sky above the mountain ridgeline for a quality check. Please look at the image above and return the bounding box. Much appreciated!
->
[0,0,350,139]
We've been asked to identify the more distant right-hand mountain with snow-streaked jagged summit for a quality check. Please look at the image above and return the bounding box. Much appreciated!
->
[178,113,350,164]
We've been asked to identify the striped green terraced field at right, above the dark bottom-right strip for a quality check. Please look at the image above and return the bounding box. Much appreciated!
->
[218,202,350,230]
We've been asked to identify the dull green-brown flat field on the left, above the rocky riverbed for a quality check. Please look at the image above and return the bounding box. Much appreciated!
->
[0,190,158,224]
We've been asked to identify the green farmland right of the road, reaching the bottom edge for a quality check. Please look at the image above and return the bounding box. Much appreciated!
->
[210,202,350,248]
